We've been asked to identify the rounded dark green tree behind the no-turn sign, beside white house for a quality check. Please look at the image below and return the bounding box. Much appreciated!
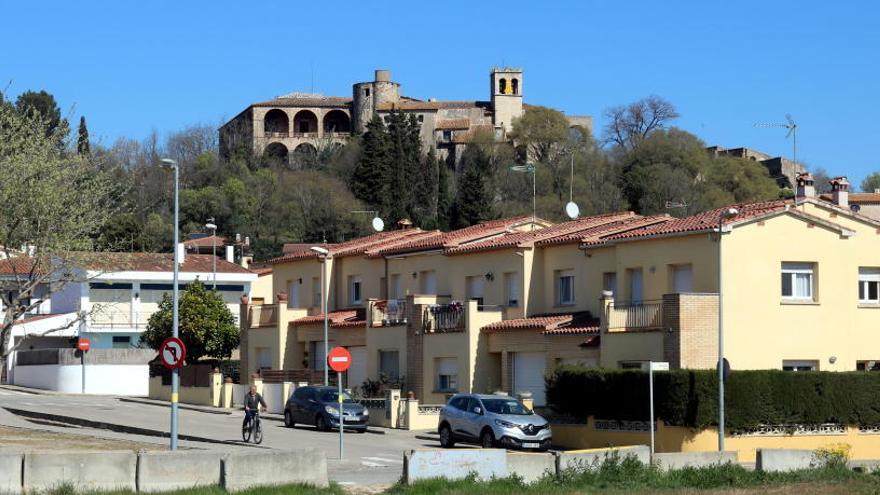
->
[141,280,239,363]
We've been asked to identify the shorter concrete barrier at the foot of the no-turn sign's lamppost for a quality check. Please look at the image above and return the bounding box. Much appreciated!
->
[137,451,223,492]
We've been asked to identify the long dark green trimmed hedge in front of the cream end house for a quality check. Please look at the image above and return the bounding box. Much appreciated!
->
[547,366,880,432]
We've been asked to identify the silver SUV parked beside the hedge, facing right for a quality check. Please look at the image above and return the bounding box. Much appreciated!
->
[437,394,552,451]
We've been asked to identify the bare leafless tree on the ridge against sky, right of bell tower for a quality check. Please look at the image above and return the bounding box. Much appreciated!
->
[604,95,679,153]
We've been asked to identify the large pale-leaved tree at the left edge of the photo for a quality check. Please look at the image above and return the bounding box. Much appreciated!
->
[0,99,119,368]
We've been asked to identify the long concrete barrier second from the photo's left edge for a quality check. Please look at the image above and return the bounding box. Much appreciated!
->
[23,451,137,492]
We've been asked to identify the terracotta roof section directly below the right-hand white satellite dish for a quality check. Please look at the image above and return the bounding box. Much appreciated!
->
[446,212,641,255]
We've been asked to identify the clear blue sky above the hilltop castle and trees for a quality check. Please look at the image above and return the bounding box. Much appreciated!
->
[0,0,880,187]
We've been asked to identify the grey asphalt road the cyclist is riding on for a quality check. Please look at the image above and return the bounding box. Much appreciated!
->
[0,388,439,485]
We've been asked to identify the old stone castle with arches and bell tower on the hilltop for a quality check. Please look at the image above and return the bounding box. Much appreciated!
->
[220,68,592,166]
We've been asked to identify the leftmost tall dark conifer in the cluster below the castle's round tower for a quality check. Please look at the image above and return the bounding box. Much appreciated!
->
[349,116,390,214]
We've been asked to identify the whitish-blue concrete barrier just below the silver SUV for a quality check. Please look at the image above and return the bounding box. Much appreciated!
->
[403,449,509,483]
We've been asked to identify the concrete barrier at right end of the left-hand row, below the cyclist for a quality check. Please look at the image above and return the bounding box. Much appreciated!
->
[222,449,328,492]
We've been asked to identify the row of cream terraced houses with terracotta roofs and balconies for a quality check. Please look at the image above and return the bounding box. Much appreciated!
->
[241,174,880,406]
